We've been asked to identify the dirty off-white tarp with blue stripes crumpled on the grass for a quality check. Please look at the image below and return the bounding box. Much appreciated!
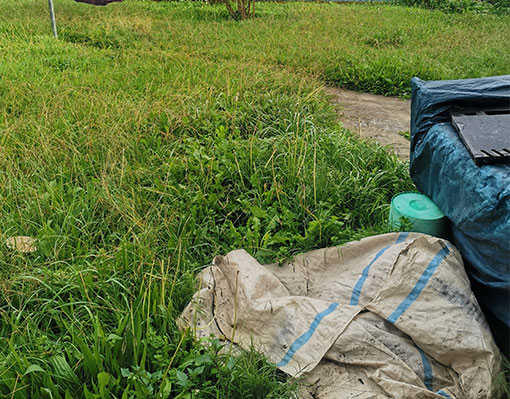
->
[179,233,501,399]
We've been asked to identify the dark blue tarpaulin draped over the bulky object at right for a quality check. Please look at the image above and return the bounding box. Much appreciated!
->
[410,75,510,352]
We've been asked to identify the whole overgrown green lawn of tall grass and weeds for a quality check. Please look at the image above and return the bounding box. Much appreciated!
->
[0,0,510,399]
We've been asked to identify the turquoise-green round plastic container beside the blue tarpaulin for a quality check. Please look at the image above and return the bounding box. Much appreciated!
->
[390,192,448,238]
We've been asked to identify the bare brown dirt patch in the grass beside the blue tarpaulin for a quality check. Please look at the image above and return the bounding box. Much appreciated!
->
[326,87,411,160]
